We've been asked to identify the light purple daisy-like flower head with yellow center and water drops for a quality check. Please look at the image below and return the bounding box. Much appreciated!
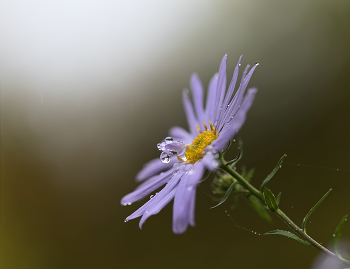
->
[121,55,259,234]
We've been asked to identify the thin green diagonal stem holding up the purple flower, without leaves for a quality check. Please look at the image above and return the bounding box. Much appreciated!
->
[220,154,350,265]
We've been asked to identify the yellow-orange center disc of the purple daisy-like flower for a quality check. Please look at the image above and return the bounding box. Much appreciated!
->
[180,121,219,164]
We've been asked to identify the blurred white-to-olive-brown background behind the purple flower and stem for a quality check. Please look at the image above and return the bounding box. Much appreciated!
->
[0,0,350,269]
